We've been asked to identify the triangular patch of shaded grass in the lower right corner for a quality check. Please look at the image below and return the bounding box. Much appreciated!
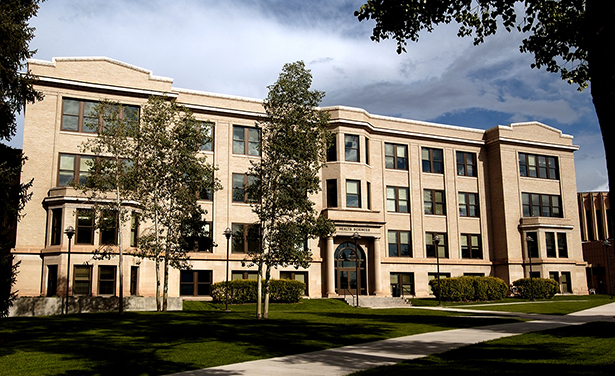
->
[353,322,615,376]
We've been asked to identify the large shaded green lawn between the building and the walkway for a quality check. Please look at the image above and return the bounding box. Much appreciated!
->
[0,299,524,375]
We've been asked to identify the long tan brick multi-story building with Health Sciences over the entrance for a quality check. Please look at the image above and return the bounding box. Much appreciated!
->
[13,58,587,297]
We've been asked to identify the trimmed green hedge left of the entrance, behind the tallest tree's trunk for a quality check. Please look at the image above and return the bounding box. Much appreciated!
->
[211,279,305,304]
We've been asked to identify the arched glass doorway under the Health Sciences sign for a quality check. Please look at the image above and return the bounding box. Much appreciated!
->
[335,242,367,295]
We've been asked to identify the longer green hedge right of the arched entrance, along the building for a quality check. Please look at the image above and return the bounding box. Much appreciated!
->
[429,276,508,302]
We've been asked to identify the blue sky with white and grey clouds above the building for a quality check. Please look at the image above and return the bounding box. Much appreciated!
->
[6,0,608,191]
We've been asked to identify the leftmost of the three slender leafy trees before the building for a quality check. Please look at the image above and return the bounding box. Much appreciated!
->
[75,101,139,315]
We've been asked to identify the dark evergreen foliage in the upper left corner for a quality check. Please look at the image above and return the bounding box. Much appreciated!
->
[0,0,43,141]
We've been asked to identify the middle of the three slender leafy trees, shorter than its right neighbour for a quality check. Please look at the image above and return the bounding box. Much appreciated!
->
[134,97,220,311]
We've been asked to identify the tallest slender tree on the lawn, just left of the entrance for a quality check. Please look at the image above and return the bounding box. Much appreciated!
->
[246,61,334,318]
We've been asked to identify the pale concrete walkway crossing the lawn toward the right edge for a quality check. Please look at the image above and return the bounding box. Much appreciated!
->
[171,303,615,376]
